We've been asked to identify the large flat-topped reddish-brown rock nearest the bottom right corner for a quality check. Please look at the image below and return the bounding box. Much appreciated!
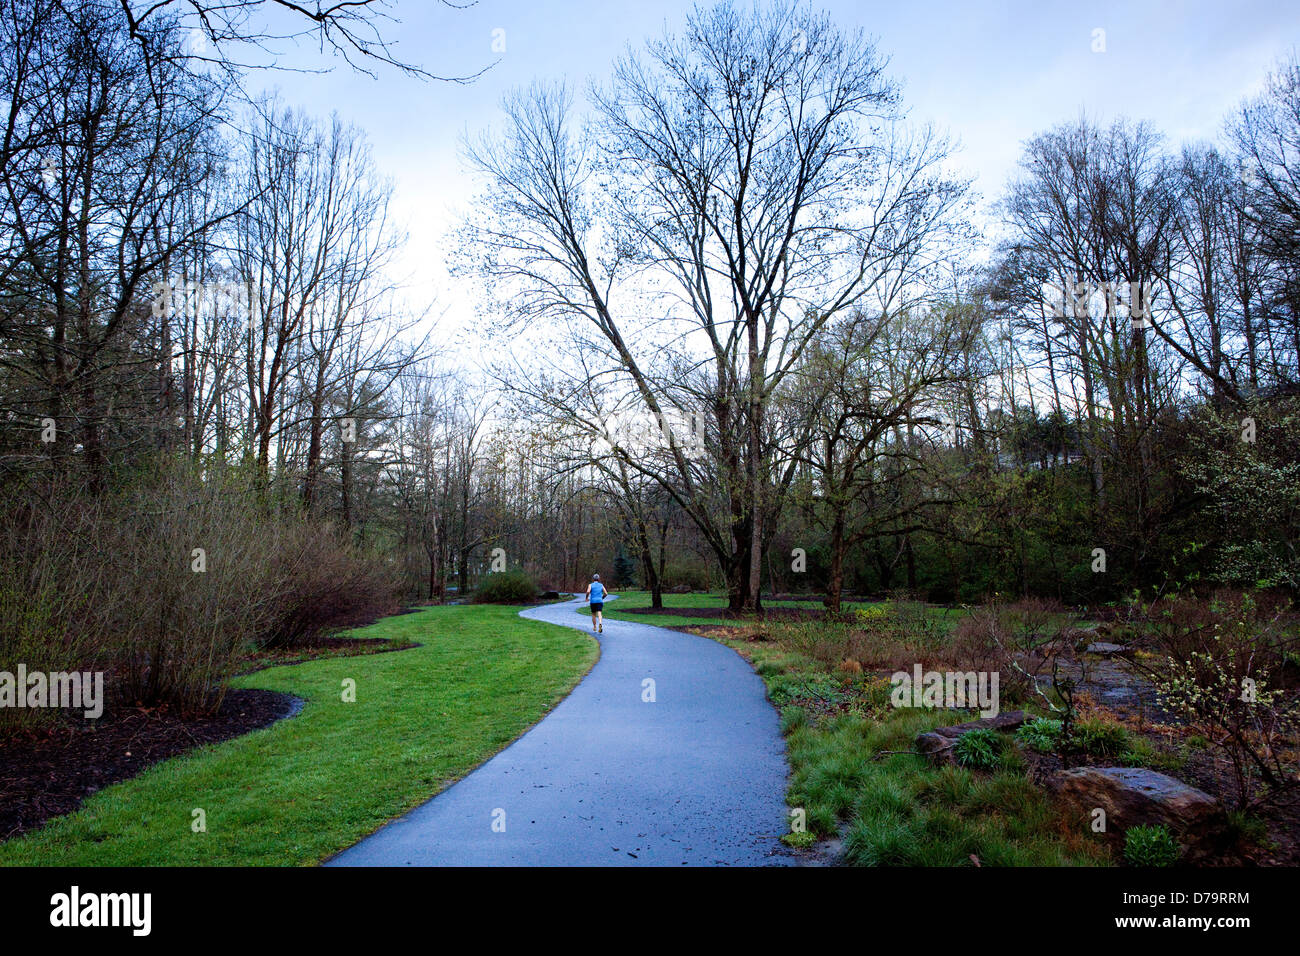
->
[1048,767,1225,852]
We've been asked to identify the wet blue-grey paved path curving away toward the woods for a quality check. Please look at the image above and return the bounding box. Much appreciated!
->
[326,601,793,866]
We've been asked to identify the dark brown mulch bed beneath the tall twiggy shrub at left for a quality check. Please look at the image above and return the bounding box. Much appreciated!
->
[0,689,299,840]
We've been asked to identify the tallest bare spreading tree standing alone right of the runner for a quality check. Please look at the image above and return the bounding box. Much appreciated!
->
[468,3,962,610]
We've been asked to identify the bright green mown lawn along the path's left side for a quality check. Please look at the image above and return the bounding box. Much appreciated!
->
[0,605,599,866]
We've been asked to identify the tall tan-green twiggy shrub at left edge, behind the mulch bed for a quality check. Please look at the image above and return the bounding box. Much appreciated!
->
[0,463,268,726]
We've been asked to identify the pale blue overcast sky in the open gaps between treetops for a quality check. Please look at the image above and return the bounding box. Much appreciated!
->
[241,0,1300,356]
